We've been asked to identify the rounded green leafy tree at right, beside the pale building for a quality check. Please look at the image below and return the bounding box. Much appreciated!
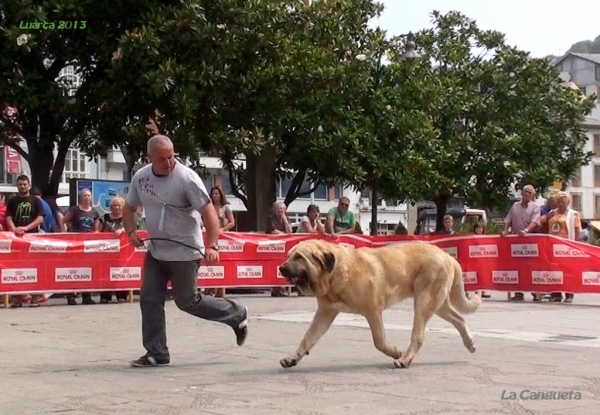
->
[414,12,594,228]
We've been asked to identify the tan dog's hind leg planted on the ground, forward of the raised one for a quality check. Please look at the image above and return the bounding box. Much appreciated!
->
[394,282,447,368]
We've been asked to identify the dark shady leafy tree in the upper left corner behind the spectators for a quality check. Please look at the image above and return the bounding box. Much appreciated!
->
[0,0,199,196]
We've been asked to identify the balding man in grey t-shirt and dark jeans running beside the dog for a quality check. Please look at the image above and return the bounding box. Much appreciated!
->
[123,135,248,367]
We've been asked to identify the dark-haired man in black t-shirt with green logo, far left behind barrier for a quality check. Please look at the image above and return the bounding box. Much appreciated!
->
[6,175,44,308]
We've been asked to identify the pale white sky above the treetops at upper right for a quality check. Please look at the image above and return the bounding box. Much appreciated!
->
[373,0,600,58]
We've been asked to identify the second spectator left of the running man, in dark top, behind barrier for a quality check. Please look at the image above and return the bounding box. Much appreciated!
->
[62,189,100,305]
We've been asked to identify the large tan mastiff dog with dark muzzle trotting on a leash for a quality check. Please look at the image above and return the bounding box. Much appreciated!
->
[279,239,481,368]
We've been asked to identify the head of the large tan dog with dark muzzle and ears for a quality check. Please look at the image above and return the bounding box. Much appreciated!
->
[279,239,336,297]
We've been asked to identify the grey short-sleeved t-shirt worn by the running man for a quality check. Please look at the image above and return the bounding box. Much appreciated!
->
[126,163,210,261]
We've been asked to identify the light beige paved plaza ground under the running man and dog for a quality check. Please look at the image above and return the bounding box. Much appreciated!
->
[0,293,600,415]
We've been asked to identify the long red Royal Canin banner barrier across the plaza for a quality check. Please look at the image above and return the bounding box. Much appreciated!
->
[0,232,600,294]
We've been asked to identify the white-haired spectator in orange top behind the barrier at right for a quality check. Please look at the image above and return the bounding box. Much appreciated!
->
[541,192,581,303]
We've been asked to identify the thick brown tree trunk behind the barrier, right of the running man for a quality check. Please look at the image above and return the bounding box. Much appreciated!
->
[244,146,277,232]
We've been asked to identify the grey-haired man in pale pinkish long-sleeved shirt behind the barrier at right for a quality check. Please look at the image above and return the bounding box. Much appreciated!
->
[502,184,540,301]
